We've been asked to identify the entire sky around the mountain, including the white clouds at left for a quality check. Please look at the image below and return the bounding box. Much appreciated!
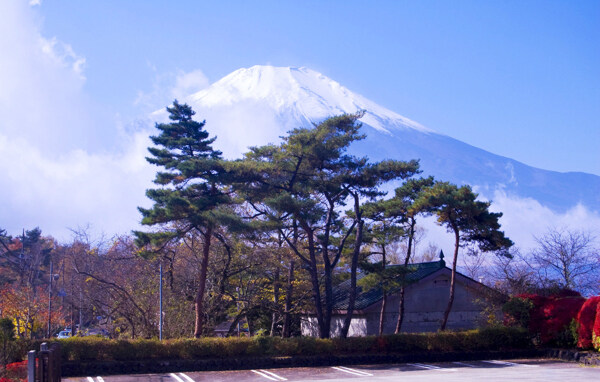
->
[0,0,600,240]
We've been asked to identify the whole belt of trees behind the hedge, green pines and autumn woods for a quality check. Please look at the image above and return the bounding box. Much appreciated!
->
[0,101,600,338]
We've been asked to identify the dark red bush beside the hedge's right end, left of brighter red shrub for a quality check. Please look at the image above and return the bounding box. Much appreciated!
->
[517,290,585,344]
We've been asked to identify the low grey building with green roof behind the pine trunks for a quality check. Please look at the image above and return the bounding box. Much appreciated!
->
[301,252,506,337]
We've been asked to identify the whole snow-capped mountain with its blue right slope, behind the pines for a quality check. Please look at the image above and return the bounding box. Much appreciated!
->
[152,66,600,213]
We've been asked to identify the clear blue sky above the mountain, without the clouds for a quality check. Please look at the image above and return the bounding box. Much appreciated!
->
[36,1,600,174]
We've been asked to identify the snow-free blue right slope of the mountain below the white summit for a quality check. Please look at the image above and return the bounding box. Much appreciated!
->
[354,126,600,213]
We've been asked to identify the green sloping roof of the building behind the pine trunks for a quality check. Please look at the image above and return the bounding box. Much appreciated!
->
[333,259,446,310]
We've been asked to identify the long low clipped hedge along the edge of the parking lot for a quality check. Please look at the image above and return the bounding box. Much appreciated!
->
[43,327,531,361]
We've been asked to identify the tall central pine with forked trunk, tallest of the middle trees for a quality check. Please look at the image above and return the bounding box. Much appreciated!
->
[238,114,363,338]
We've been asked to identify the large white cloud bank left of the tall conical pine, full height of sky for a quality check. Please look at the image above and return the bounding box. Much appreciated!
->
[0,0,155,240]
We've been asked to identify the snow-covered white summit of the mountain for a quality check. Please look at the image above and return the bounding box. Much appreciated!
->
[189,65,432,134]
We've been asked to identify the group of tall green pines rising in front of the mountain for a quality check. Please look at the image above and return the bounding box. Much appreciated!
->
[135,101,512,338]
